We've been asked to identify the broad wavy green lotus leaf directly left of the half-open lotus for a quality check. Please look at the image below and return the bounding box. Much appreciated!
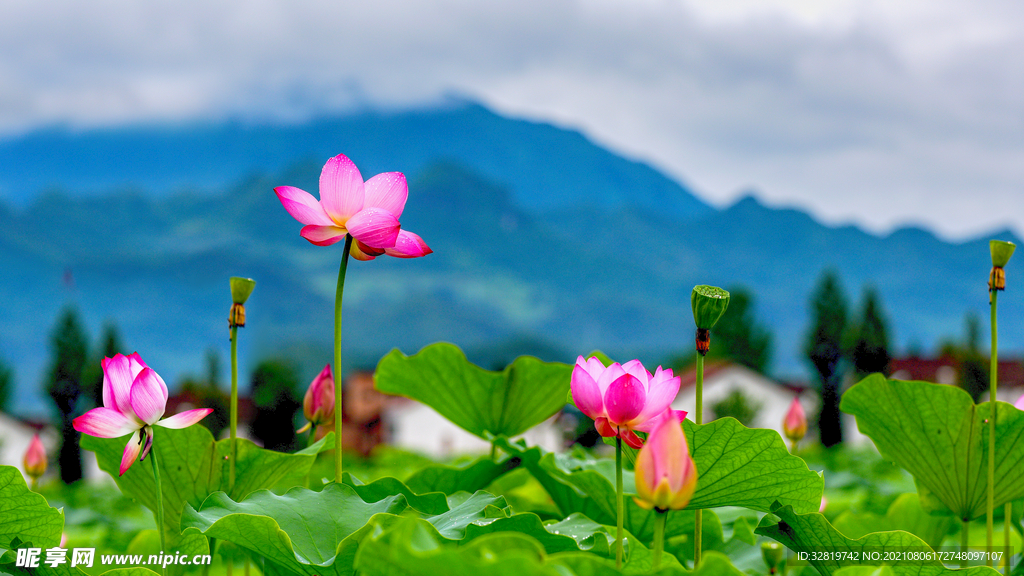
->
[376,342,572,440]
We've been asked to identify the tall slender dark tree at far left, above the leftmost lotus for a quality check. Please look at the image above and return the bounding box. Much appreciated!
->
[46,306,88,484]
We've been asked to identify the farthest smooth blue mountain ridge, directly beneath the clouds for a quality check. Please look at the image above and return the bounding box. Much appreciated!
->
[0,102,713,217]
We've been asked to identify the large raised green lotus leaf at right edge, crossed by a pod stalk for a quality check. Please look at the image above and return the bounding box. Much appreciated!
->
[843,374,1024,520]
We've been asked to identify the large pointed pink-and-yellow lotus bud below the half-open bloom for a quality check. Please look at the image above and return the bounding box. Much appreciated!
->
[634,414,697,511]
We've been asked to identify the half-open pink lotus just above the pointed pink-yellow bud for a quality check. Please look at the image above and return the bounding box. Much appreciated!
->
[570,356,686,448]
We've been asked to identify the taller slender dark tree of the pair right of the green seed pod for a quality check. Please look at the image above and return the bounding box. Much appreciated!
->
[804,271,847,446]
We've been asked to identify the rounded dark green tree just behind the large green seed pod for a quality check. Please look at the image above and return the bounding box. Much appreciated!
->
[712,287,771,373]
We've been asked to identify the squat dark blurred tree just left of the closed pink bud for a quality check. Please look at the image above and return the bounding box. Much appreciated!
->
[250,360,302,450]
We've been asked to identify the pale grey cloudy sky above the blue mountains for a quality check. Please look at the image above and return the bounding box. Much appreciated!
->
[0,0,1024,239]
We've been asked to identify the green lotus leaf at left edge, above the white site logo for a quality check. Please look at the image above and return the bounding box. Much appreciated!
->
[0,466,63,548]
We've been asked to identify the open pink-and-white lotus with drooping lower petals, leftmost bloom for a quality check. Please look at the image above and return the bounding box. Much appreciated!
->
[72,353,213,475]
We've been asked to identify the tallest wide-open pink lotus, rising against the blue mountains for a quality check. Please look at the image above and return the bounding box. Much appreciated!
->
[273,154,433,260]
